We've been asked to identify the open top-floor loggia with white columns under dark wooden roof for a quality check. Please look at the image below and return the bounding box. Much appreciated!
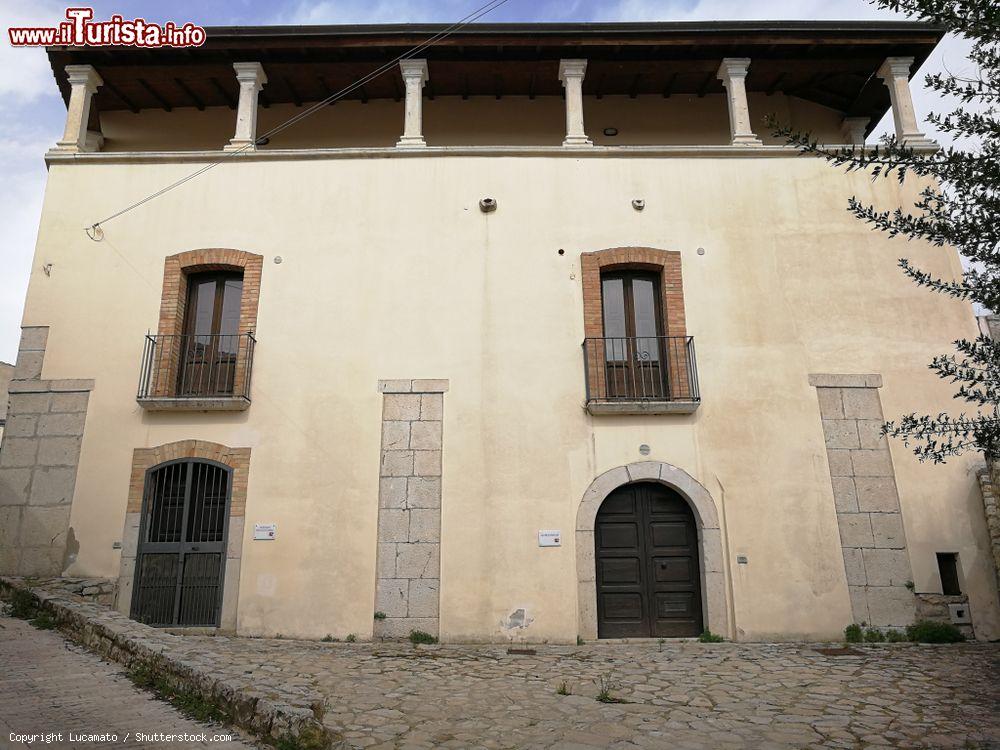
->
[49,22,940,157]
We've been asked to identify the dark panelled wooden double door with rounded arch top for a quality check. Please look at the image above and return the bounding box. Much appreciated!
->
[594,482,703,638]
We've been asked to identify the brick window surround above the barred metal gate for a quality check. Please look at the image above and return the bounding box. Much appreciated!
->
[151,248,264,396]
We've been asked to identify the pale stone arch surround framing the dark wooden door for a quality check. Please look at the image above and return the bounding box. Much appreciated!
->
[576,461,732,640]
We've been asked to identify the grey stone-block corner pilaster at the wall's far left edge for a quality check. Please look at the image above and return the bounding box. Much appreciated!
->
[0,326,94,576]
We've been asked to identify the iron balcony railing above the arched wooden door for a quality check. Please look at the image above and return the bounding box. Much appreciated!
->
[583,336,701,403]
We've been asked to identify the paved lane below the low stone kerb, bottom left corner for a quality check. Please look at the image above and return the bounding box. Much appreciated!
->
[0,617,256,750]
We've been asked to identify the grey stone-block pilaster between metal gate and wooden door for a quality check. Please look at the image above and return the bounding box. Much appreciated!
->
[375,380,448,638]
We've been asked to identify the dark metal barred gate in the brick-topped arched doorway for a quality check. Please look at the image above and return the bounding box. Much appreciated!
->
[131,459,232,627]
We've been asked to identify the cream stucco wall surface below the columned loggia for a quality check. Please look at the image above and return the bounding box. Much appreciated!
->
[24,154,1000,641]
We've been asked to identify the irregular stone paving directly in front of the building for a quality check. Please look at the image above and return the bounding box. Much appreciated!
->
[168,637,1000,750]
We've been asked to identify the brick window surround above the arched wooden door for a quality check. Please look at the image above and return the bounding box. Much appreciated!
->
[580,247,689,399]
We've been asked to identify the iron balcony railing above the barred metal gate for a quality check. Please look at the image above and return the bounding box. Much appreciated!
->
[138,332,257,401]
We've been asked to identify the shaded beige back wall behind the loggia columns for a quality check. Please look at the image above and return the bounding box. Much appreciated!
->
[101,94,842,151]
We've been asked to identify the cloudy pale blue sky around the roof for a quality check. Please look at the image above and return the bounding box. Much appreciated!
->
[0,0,970,362]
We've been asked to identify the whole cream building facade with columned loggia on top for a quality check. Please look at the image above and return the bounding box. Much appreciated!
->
[0,23,1000,642]
